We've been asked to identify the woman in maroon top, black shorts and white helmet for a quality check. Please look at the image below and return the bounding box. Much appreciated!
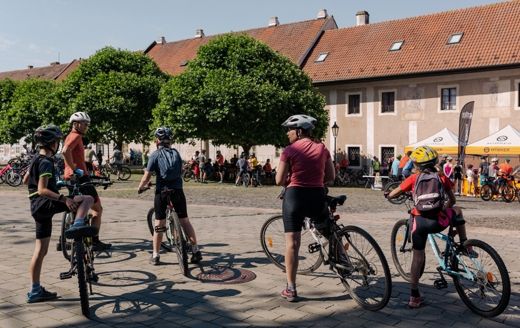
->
[276,115,335,302]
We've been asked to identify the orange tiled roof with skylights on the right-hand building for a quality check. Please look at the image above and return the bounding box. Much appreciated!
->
[303,1,520,83]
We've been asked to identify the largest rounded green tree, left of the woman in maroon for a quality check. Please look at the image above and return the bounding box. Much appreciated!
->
[153,34,328,152]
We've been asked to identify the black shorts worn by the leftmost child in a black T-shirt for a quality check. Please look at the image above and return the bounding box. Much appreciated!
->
[31,197,68,239]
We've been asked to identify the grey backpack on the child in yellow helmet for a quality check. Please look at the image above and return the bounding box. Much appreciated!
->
[413,172,446,216]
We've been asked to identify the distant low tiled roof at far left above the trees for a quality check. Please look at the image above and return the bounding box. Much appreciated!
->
[0,60,79,81]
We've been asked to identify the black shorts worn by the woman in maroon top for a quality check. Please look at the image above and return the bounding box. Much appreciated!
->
[282,187,328,232]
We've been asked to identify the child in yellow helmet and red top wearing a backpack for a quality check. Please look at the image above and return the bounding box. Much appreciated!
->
[385,146,471,308]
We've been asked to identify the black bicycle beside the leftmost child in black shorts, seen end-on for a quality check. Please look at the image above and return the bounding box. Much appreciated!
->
[59,181,111,318]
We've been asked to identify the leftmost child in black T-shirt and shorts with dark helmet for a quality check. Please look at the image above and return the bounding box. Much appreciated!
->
[24,125,94,303]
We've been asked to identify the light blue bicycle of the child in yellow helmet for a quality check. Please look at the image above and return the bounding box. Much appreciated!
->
[391,198,511,317]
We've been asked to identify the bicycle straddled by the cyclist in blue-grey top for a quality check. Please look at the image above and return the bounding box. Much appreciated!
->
[139,187,191,277]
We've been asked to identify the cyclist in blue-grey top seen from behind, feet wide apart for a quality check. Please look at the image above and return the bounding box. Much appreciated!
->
[138,127,202,265]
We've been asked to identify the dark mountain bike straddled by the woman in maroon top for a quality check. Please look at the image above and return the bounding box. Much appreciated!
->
[260,190,392,311]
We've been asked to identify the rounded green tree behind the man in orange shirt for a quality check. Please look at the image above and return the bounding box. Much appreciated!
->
[56,47,167,146]
